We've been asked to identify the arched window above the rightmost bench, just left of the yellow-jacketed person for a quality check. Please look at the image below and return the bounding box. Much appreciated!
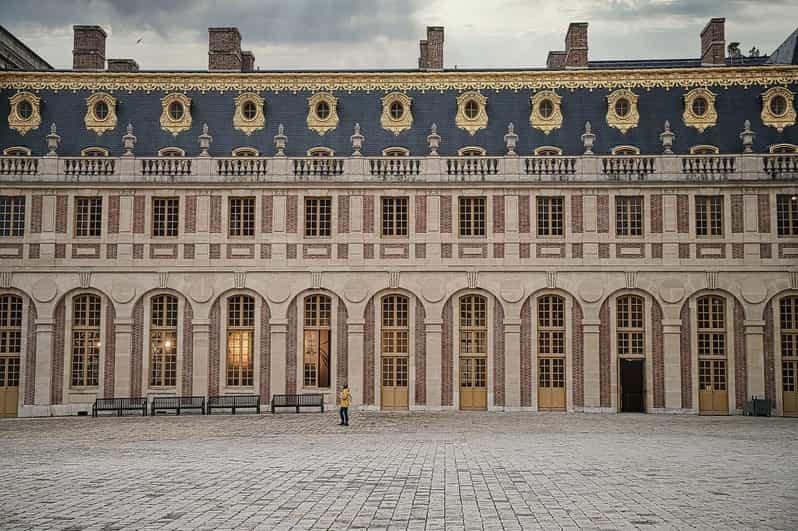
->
[303,295,331,387]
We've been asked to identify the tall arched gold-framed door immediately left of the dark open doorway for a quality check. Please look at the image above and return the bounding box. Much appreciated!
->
[538,295,565,411]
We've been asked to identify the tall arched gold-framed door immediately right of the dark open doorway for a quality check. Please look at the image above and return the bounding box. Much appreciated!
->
[696,295,728,413]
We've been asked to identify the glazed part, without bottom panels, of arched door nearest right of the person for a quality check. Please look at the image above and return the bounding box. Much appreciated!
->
[382,295,410,387]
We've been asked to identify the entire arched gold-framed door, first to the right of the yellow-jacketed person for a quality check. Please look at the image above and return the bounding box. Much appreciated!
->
[380,295,410,409]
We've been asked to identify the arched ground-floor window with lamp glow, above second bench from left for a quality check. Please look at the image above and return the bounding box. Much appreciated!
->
[150,295,177,387]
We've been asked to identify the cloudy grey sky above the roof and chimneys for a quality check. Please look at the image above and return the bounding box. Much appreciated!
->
[0,0,798,70]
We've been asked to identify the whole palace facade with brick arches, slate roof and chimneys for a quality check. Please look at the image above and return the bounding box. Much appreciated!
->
[0,19,798,416]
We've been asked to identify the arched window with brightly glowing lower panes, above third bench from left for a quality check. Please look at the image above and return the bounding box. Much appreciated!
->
[227,295,255,387]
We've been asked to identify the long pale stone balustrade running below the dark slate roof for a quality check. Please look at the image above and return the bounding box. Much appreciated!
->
[0,154,798,183]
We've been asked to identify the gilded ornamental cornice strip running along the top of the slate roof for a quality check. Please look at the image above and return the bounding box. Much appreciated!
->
[0,65,798,93]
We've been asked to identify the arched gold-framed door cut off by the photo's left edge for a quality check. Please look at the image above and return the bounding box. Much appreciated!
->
[0,294,23,406]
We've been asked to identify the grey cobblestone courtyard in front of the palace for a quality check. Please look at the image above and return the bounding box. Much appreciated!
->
[0,413,798,529]
